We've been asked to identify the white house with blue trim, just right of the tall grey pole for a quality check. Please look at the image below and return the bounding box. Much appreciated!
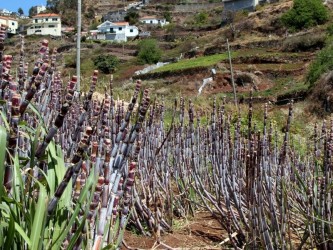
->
[97,21,139,42]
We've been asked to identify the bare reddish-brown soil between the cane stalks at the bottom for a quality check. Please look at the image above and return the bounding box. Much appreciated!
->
[121,212,228,249]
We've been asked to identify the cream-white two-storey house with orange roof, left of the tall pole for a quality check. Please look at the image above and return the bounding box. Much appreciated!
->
[27,13,61,36]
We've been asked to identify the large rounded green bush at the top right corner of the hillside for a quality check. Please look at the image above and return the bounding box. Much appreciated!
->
[281,0,329,30]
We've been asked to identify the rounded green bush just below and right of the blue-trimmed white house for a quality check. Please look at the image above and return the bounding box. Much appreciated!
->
[138,39,162,64]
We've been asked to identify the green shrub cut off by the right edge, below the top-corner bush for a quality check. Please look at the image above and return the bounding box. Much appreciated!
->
[306,41,333,87]
